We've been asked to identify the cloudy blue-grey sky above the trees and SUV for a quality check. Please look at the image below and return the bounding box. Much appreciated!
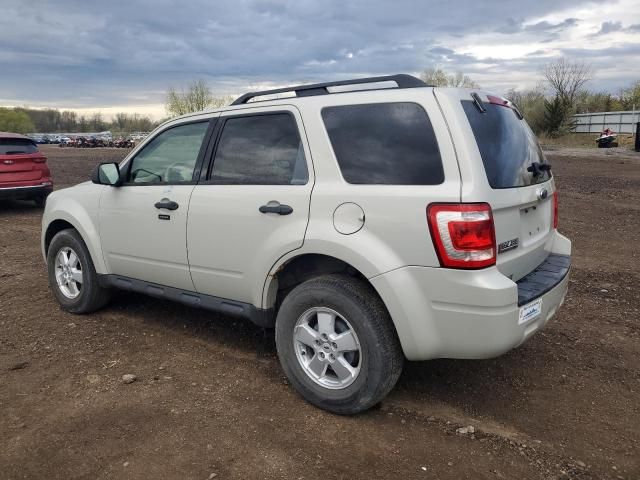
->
[0,0,640,118]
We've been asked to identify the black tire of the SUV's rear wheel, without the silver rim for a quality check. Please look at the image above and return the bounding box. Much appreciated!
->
[276,274,404,415]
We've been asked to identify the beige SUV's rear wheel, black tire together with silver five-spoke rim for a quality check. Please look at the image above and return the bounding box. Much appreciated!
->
[276,275,404,414]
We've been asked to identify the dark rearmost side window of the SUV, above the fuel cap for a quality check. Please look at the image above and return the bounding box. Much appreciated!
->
[322,103,444,185]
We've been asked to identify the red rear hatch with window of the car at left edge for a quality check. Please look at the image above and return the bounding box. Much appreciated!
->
[0,136,46,188]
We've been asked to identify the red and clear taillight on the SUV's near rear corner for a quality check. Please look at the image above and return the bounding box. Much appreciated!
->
[427,203,496,268]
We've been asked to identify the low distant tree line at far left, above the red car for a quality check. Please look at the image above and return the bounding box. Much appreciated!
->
[0,107,158,133]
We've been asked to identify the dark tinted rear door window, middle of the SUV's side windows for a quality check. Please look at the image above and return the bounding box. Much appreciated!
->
[211,113,309,185]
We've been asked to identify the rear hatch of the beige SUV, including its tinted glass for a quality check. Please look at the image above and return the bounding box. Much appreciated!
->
[436,89,555,281]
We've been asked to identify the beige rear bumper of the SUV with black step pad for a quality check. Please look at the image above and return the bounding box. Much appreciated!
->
[371,234,571,360]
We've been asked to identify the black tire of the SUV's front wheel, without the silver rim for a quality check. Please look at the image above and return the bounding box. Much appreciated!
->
[47,228,111,313]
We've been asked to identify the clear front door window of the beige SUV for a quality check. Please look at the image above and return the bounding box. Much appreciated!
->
[127,121,209,184]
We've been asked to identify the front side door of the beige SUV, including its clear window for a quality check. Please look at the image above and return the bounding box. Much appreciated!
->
[100,119,214,291]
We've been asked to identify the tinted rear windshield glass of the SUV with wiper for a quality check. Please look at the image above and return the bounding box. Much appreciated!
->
[462,100,551,188]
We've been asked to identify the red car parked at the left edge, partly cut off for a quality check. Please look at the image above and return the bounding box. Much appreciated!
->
[0,132,53,206]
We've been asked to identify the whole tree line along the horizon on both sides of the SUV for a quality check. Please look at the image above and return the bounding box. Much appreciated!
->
[0,58,640,136]
